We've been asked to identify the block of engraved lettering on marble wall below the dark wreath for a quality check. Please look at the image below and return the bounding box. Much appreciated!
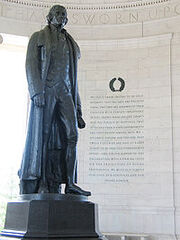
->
[88,94,144,182]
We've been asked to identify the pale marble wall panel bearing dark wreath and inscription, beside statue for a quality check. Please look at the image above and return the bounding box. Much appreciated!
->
[79,34,174,238]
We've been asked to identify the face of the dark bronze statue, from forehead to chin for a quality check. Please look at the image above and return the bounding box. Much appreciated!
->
[51,6,67,28]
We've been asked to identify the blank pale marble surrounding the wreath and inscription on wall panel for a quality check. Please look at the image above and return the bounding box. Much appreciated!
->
[79,34,174,238]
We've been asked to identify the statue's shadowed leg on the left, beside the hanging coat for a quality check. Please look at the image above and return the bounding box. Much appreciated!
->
[39,87,56,193]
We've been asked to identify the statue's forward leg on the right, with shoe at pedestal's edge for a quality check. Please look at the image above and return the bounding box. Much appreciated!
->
[58,94,91,196]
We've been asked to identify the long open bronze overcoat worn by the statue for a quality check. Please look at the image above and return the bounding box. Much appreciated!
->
[18,26,81,182]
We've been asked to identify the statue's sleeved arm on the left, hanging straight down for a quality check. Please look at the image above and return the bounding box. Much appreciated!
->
[26,32,44,99]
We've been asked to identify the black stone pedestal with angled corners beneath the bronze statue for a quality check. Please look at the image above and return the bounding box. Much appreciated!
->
[1,194,102,239]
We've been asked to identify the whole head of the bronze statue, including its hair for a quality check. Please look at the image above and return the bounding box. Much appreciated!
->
[47,5,68,28]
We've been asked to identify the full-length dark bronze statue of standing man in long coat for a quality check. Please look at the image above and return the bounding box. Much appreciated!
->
[19,5,91,196]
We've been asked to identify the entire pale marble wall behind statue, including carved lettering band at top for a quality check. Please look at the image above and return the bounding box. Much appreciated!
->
[0,0,180,240]
